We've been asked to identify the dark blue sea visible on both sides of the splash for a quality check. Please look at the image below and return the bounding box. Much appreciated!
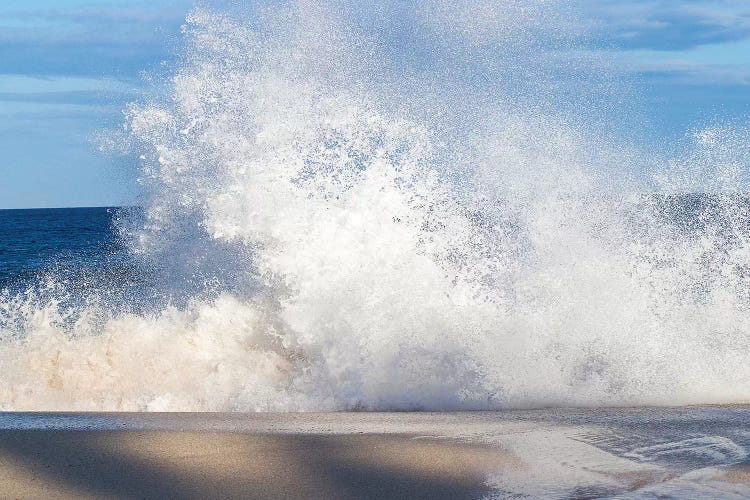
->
[0,195,750,307]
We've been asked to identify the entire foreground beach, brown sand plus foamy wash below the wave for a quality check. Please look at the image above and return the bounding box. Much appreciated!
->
[0,407,750,499]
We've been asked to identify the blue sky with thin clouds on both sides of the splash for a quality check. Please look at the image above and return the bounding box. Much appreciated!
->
[0,0,750,208]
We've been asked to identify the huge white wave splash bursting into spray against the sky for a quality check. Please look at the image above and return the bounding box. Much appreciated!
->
[0,0,750,411]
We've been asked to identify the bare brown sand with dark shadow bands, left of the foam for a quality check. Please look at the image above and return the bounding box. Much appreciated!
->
[0,430,519,499]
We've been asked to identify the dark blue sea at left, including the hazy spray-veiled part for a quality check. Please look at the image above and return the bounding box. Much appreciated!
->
[0,207,253,311]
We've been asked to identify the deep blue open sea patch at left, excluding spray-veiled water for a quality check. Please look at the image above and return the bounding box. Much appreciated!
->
[0,207,132,290]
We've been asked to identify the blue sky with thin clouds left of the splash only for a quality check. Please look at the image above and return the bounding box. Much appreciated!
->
[0,0,192,208]
